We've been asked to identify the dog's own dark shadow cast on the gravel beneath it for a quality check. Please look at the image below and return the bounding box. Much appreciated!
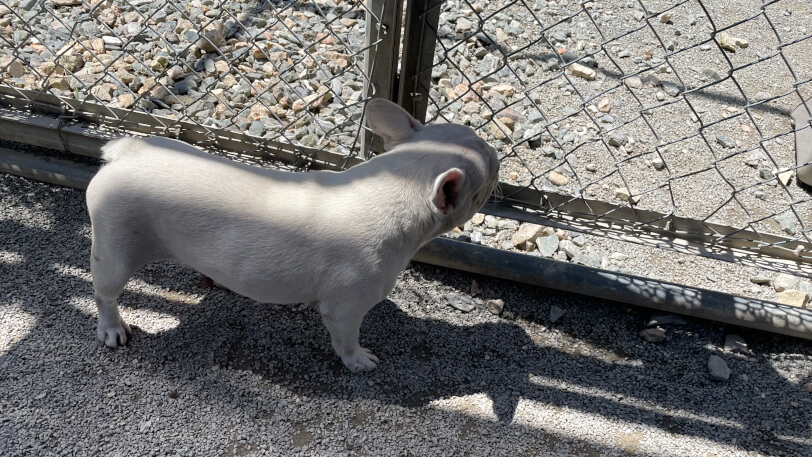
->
[121,276,534,422]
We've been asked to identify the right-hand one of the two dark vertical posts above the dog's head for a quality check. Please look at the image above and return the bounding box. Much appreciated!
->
[398,0,443,122]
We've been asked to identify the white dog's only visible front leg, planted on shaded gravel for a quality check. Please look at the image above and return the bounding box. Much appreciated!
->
[319,302,378,373]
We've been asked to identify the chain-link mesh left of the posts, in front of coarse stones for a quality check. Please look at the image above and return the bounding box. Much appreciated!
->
[0,0,386,164]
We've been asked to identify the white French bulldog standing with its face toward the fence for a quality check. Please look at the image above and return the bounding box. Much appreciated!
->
[87,99,499,372]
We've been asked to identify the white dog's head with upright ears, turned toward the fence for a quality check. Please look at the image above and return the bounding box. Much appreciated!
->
[366,99,499,230]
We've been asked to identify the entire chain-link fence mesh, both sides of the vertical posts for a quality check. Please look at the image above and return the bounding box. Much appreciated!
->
[0,0,812,268]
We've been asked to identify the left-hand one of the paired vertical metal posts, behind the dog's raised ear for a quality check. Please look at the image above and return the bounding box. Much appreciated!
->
[361,0,403,158]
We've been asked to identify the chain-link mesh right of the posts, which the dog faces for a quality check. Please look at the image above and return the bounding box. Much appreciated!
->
[407,0,812,258]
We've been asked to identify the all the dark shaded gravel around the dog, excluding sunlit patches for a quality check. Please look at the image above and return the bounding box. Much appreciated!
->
[0,173,812,456]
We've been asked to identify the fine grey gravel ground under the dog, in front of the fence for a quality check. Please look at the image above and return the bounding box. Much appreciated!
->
[0,175,812,457]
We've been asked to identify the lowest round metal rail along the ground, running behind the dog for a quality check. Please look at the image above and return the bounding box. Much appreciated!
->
[0,149,812,339]
